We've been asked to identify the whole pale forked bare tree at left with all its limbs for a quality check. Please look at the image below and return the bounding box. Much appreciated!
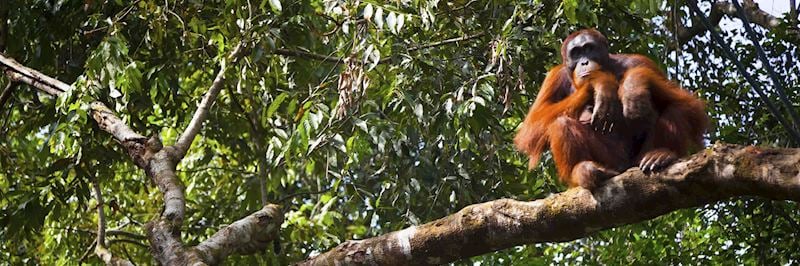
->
[0,49,283,265]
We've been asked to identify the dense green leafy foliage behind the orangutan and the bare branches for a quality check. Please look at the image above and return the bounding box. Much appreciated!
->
[0,0,800,265]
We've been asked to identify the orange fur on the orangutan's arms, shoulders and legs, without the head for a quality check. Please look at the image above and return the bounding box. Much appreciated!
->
[514,66,708,187]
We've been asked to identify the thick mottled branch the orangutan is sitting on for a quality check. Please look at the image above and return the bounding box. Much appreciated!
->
[300,144,800,265]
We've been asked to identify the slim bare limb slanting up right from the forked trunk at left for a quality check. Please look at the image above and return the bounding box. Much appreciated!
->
[175,42,244,159]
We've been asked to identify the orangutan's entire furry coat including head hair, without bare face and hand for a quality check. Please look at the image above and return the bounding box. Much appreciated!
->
[514,30,708,188]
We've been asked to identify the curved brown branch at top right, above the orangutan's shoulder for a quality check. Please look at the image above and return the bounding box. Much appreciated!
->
[673,0,781,45]
